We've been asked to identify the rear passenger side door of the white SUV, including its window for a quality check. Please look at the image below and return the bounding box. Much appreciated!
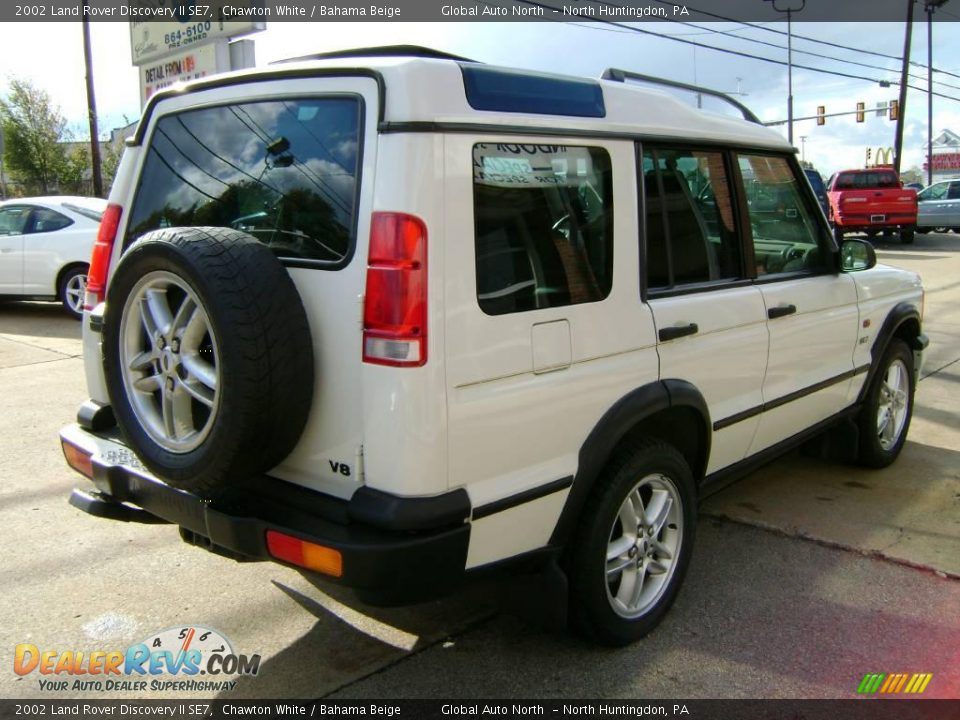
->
[642,144,767,474]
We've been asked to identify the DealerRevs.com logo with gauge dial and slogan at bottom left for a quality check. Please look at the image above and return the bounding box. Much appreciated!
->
[13,625,260,692]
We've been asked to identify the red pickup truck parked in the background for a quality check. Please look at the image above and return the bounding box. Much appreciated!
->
[827,167,917,243]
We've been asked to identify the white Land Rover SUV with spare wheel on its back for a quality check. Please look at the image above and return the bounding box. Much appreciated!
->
[61,48,926,644]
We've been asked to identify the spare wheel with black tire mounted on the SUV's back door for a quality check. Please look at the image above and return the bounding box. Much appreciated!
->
[103,228,313,497]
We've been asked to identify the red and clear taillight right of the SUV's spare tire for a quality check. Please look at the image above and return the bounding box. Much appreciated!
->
[363,212,427,367]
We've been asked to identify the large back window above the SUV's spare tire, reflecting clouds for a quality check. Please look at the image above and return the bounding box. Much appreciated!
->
[126,97,362,263]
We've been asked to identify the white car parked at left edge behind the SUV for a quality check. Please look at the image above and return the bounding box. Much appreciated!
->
[0,196,107,319]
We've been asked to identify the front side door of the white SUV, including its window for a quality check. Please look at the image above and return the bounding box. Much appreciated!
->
[736,152,865,454]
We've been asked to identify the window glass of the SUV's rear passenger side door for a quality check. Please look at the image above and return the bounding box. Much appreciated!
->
[643,148,744,289]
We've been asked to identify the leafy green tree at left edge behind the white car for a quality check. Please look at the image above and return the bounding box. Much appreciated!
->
[0,78,71,194]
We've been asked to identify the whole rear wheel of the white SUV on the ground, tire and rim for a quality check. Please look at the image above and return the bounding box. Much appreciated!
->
[568,440,697,646]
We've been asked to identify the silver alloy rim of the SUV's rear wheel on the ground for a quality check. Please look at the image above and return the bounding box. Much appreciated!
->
[606,473,683,619]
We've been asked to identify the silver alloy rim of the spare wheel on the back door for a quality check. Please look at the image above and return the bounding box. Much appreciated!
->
[120,270,221,453]
